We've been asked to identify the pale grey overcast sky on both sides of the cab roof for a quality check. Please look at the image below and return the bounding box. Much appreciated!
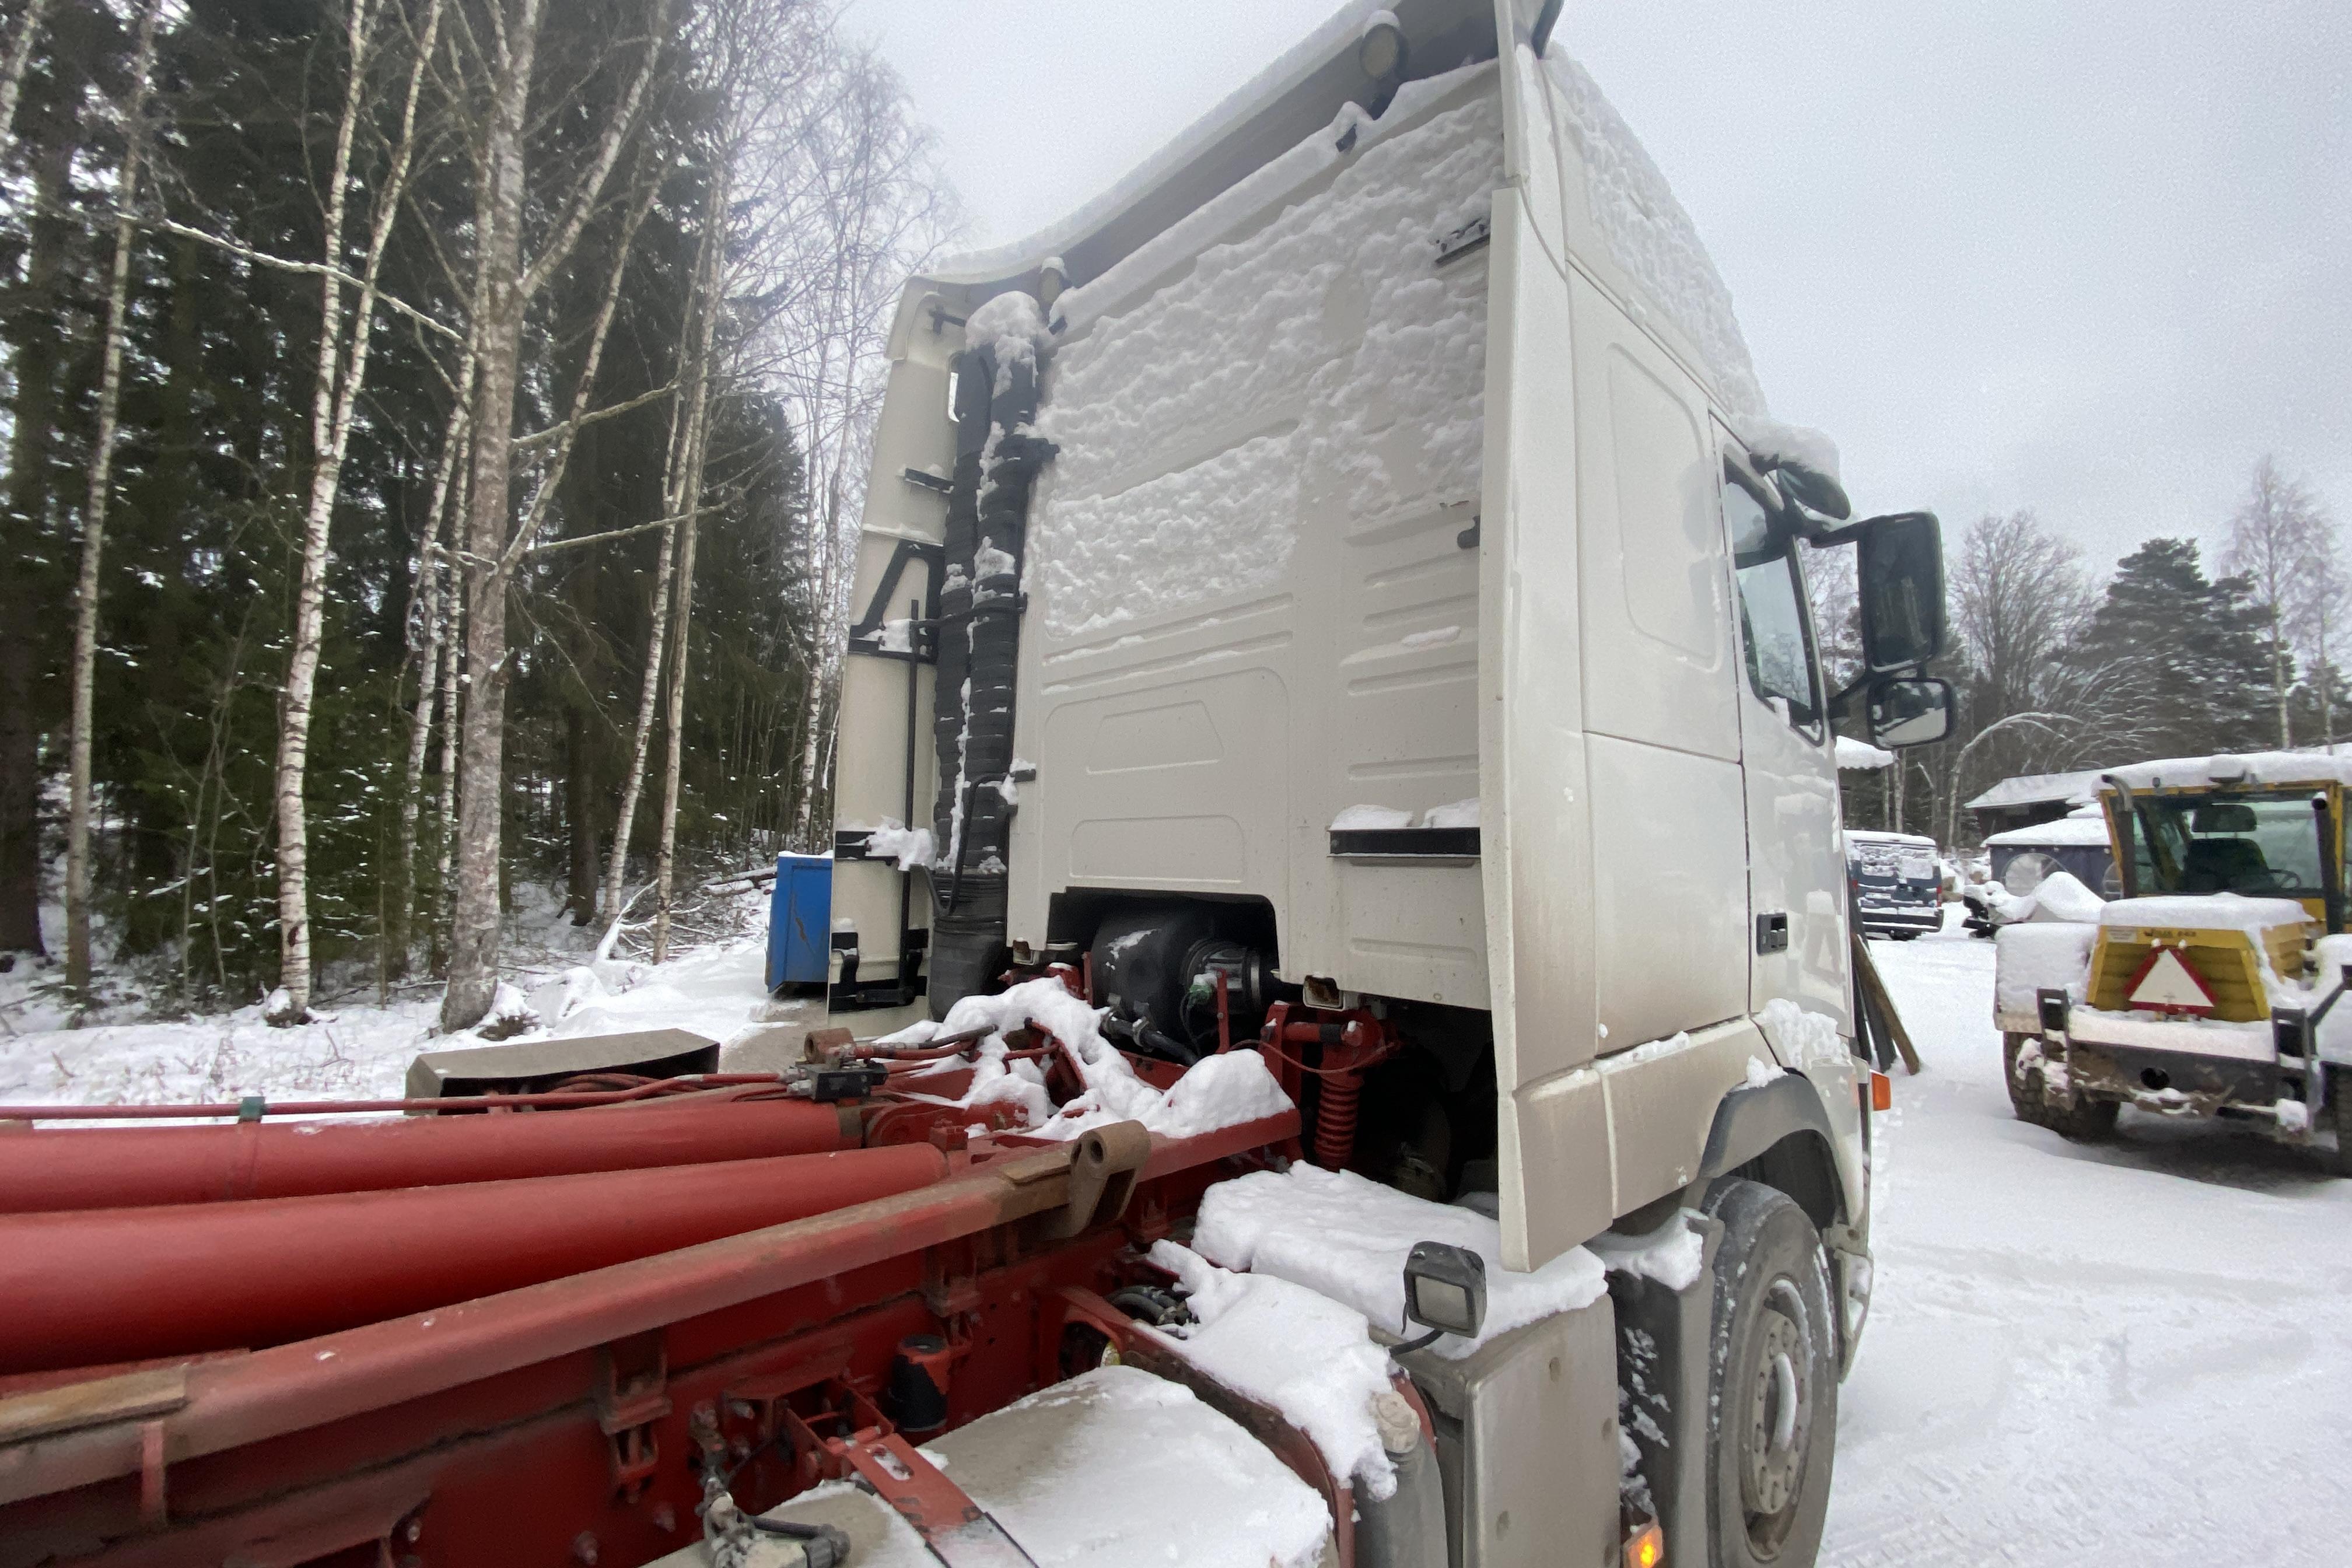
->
[852,0,2352,583]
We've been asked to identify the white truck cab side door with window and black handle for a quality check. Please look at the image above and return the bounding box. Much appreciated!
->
[1717,442,1853,1034]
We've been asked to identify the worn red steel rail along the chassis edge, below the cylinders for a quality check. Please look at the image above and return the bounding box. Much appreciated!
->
[0,1112,1298,1504]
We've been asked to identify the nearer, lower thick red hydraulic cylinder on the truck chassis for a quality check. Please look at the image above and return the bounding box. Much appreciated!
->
[0,1143,948,1373]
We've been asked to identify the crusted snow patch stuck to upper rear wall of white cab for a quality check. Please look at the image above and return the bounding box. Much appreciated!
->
[1030,83,1500,637]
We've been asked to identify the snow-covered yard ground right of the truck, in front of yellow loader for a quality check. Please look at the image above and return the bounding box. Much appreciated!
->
[1821,931,2352,1568]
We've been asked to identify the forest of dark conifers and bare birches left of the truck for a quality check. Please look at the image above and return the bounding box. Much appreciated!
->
[0,0,953,1027]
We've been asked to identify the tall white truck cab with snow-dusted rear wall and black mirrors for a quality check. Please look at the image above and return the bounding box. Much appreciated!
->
[830,0,1950,1561]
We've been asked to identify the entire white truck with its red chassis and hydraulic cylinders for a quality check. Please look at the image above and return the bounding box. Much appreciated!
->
[0,0,1950,1568]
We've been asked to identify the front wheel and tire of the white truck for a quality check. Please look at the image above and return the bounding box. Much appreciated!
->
[1707,1178,1839,1568]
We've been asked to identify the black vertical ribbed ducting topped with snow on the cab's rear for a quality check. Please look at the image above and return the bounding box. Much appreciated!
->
[929,292,1054,1018]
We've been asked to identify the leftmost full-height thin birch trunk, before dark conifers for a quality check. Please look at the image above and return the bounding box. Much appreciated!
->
[66,0,162,1002]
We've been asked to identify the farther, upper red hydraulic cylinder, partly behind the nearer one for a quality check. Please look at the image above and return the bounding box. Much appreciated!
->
[0,1100,859,1213]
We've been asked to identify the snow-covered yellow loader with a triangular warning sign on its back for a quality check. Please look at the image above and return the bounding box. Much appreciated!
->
[1994,752,2352,1175]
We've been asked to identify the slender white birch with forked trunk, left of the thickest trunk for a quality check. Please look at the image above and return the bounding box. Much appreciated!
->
[271,0,442,1025]
